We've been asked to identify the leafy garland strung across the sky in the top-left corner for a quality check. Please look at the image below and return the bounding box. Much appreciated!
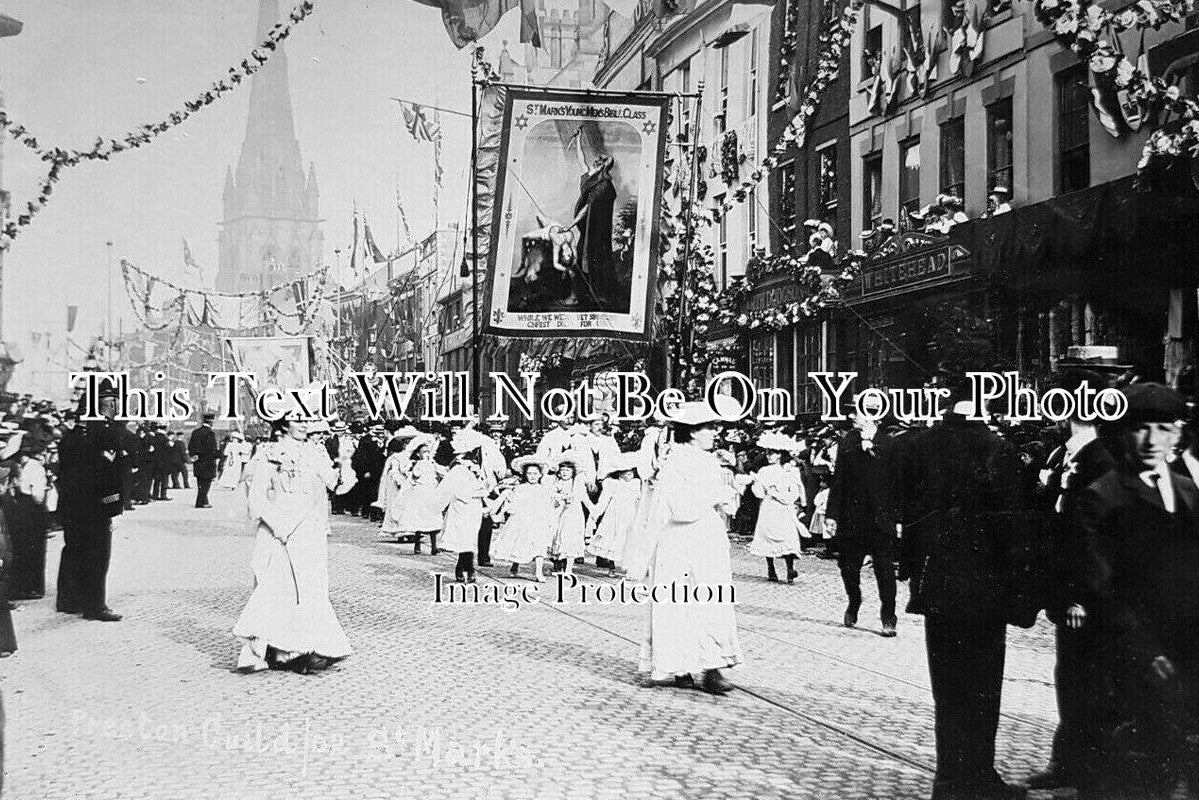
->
[0,0,314,251]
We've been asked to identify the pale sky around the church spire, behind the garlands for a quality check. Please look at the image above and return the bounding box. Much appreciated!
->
[0,0,529,369]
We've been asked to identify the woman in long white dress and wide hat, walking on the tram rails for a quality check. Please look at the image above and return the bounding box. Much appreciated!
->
[640,403,742,694]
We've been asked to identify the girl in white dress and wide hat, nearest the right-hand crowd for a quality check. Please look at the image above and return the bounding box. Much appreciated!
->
[749,431,807,583]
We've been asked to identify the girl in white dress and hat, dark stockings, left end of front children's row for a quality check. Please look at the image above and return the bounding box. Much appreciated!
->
[438,428,488,583]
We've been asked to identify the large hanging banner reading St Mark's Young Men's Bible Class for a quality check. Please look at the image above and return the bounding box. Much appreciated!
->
[484,88,669,339]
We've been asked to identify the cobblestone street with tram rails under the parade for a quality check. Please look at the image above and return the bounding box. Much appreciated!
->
[0,489,1055,800]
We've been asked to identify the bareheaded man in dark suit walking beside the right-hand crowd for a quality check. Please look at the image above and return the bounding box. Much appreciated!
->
[825,398,898,637]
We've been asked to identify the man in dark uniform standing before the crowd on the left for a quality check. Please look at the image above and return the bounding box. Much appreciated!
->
[56,389,125,622]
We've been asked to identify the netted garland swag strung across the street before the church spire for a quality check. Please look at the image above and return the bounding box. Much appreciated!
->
[121,259,329,336]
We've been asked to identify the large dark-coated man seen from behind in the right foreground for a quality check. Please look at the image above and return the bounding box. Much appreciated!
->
[899,388,1036,800]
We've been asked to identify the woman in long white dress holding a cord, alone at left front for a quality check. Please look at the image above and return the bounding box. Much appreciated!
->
[233,420,350,673]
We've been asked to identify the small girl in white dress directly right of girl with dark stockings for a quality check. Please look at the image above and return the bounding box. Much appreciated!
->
[489,455,558,583]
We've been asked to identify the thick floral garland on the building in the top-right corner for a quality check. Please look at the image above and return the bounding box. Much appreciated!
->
[1035,0,1199,172]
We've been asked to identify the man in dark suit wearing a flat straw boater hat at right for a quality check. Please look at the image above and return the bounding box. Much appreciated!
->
[1028,369,1116,789]
